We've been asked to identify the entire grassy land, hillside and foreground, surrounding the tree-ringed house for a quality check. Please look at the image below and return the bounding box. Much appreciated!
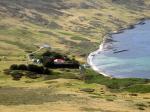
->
[0,0,150,112]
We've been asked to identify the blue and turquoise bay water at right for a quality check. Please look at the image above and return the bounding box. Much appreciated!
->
[92,20,150,79]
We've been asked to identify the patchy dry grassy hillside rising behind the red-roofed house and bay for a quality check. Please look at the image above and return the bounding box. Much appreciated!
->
[0,0,150,60]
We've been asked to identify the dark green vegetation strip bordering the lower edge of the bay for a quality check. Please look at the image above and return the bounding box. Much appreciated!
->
[85,70,150,93]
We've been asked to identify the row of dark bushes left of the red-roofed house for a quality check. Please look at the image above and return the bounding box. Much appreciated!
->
[4,64,52,80]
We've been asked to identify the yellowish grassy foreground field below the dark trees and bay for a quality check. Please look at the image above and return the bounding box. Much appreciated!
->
[0,61,150,112]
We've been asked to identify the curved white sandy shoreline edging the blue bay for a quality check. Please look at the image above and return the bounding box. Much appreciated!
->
[87,18,148,78]
